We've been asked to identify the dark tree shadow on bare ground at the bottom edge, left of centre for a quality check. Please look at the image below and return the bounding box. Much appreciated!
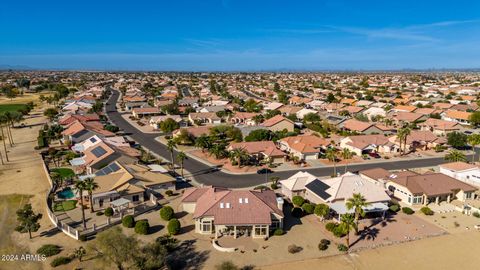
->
[167,240,210,270]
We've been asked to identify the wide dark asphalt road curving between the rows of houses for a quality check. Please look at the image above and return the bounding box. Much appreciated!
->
[106,89,472,188]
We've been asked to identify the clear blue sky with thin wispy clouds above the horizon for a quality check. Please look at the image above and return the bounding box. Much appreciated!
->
[0,0,480,71]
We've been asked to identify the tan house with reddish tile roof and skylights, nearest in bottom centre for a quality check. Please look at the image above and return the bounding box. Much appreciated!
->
[181,186,284,238]
